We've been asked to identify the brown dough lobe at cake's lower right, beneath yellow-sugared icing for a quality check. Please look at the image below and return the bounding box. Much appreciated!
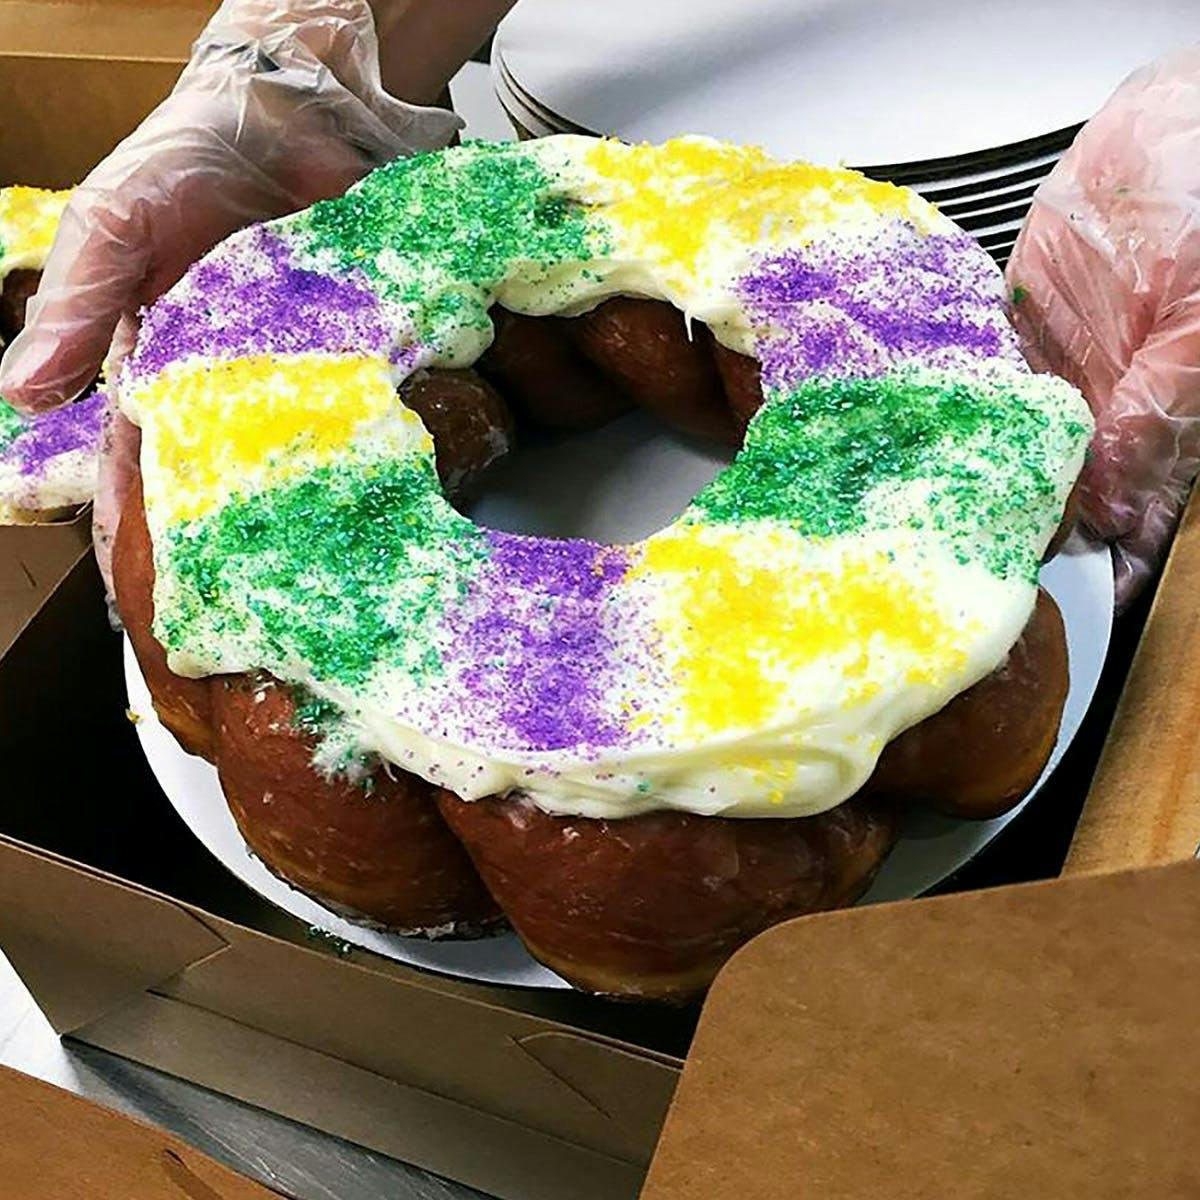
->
[864,588,1068,820]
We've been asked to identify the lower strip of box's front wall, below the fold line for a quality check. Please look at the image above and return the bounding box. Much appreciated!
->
[82,993,644,1200]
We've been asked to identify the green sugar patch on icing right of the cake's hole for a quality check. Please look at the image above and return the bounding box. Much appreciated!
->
[685,371,1086,578]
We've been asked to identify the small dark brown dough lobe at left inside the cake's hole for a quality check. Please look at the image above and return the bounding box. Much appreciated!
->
[400,371,515,498]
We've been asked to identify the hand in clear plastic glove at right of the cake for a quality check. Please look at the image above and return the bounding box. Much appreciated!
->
[1008,47,1200,607]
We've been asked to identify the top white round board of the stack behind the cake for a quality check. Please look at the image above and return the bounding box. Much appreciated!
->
[493,0,1200,166]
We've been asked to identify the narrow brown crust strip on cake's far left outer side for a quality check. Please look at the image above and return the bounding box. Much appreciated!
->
[113,469,212,761]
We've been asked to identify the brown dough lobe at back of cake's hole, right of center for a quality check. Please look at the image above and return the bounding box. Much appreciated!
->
[568,296,742,445]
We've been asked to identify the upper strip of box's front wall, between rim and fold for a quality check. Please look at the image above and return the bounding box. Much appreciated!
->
[156,918,678,1166]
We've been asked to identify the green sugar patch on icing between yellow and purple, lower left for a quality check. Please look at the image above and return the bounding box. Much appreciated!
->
[156,456,487,691]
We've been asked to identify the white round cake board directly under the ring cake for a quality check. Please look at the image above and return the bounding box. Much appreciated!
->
[125,413,1112,988]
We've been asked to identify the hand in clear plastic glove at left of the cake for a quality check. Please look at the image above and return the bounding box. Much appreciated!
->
[0,0,461,410]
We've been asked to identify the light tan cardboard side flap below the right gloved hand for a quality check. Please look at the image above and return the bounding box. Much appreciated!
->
[1063,493,1200,875]
